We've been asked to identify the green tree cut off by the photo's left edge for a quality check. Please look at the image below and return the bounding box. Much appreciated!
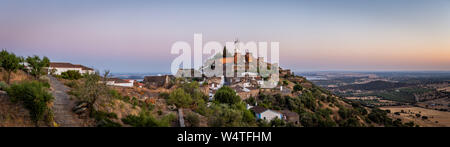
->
[0,50,20,84]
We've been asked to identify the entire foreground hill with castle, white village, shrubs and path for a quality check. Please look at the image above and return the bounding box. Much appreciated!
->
[0,48,415,127]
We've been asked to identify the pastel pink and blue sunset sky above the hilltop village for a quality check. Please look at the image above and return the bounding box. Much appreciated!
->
[0,0,450,72]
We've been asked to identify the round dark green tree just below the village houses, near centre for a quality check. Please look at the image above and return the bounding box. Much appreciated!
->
[214,86,241,105]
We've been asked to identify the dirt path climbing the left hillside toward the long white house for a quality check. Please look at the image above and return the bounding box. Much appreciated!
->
[49,76,84,127]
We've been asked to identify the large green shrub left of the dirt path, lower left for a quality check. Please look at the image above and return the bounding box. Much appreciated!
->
[7,81,53,123]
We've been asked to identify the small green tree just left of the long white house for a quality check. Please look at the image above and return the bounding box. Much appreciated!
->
[25,56,50,79]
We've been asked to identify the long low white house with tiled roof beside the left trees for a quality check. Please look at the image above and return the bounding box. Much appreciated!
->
[48,62,95,75]
